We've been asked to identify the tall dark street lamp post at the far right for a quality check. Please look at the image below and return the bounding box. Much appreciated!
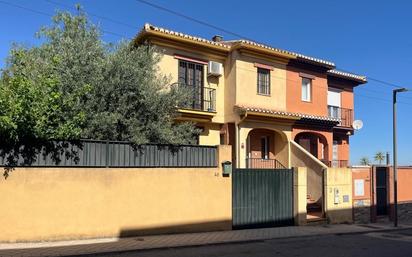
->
[393,88,408,227]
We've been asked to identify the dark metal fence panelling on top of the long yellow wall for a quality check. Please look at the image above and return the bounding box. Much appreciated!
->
[0,140,217,167]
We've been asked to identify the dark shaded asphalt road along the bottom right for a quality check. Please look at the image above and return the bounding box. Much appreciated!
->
[89,229,412,257]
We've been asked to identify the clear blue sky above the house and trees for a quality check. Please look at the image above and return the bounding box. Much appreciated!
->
[0,0,412,165]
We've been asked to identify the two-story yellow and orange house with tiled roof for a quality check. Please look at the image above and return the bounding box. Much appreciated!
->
[135,24,366,168]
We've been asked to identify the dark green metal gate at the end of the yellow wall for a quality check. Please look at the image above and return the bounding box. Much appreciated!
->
[232,169,294,229]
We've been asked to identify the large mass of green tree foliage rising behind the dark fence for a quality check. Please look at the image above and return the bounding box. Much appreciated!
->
[0,8,198,175]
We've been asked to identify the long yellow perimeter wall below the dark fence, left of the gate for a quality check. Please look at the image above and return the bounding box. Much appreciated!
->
[0,146,232,242]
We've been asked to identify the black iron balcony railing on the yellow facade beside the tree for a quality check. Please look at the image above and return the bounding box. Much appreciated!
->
[175,83,216,112]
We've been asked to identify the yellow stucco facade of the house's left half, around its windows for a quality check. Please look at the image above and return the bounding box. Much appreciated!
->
[145,36,292,167]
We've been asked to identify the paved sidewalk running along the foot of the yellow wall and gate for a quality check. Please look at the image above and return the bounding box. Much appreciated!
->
[0,223,412,257]
